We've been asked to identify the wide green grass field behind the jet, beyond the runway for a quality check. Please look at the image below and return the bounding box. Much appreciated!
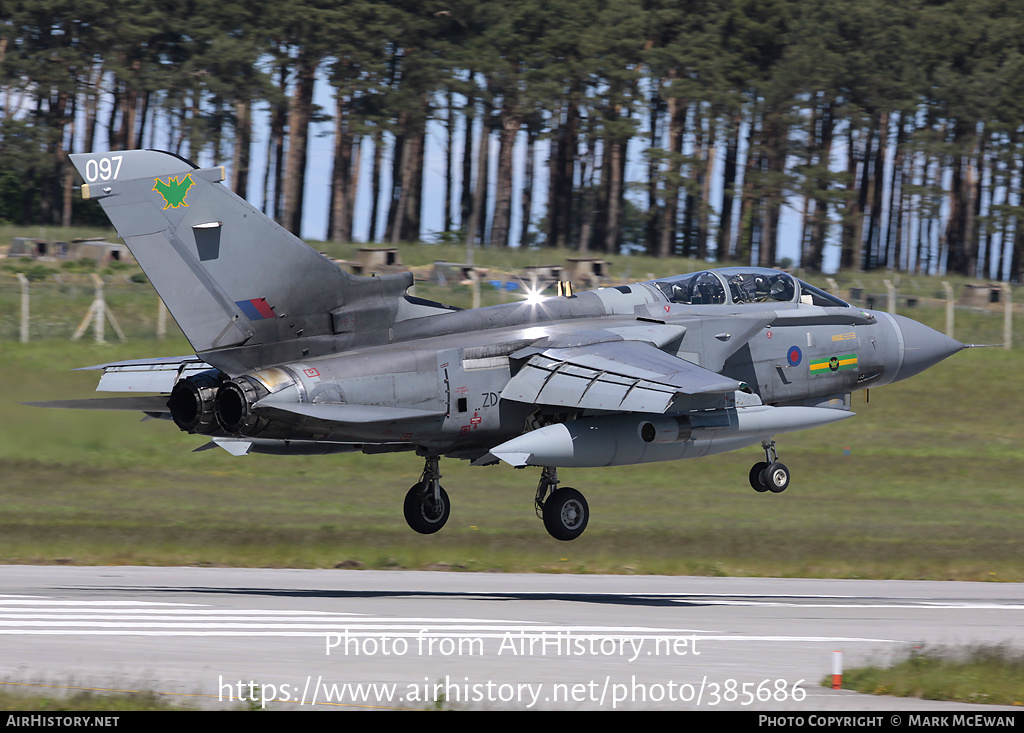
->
[0,230,1024,580]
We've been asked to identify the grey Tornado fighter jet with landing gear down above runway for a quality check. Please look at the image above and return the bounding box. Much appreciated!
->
[37,150,965,541]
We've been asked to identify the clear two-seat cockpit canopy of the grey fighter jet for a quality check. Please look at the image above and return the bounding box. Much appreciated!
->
[648,267,850,308]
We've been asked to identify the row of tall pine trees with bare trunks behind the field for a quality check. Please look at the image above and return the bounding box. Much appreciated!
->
[0,0,1024,282]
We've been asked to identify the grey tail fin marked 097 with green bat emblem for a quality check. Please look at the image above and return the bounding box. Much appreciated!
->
[71,150,412,361]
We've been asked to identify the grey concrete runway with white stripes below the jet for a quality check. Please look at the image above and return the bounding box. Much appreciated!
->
[0,566,1024,710]
